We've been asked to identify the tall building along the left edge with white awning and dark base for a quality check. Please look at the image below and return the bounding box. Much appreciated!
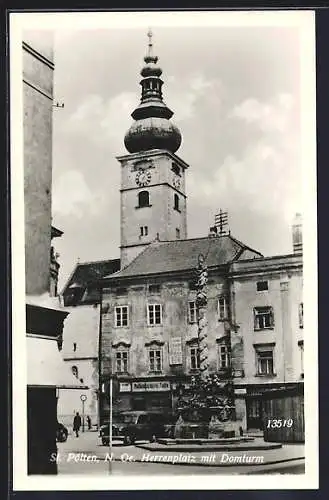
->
[21,31,82,474]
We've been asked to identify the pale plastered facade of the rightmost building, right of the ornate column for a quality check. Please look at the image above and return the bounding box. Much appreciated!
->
[229,253,304,429]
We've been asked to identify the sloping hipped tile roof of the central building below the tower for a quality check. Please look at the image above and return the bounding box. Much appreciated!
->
[104,235,262,280]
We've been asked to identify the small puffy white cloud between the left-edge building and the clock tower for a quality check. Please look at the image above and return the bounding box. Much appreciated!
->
[52,170,106,219]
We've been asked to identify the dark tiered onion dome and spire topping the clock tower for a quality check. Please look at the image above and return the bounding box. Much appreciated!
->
[124,31,182,153]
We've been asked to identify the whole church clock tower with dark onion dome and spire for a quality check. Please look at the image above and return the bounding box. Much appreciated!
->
[117,31,188,267]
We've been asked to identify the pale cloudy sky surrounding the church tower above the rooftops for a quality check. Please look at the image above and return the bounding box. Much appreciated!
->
[48,15,302,288]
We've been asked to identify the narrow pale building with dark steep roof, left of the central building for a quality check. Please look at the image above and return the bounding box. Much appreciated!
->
[58,259,120,427]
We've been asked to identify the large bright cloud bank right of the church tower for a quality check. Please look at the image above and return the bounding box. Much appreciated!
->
[188,94,302,227]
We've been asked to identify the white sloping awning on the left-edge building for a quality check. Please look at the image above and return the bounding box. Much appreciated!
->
[26,335,88,389]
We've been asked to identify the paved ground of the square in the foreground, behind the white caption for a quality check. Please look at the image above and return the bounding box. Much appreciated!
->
[57,431,305,475]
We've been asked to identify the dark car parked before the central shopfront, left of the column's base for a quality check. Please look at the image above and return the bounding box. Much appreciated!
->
[100,411,175,446]
